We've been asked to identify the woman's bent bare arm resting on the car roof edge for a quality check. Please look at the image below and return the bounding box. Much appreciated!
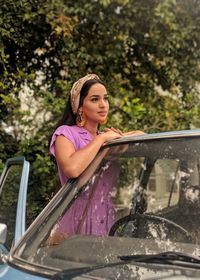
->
[55,130,121,178]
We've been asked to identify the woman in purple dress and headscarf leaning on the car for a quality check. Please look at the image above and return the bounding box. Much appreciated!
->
[49,74,143,243]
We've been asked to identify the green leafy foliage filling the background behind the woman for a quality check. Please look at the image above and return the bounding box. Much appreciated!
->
[0,0,200,219]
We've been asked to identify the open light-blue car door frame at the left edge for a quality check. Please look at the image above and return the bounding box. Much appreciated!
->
[0,156,30,253]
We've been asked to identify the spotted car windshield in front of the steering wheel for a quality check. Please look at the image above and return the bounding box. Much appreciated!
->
[13,137,200,270]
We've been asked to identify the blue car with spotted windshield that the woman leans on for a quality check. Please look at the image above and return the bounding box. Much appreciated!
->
[0,129,200,280]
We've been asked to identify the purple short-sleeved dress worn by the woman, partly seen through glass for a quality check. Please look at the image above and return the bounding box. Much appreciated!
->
[50,125,118,235]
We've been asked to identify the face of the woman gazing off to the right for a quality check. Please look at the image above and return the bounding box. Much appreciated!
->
[80,83,109,124]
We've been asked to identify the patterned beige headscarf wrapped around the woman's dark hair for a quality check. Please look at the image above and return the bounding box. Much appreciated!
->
[70,74,99,114]
